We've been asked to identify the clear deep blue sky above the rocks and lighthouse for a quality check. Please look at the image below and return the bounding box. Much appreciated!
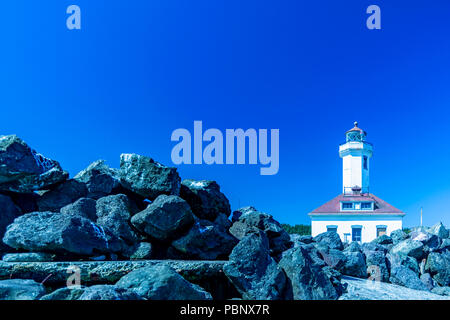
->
[0,0,450,226]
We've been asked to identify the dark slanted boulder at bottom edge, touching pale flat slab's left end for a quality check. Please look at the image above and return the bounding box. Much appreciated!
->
[279,246,338,300]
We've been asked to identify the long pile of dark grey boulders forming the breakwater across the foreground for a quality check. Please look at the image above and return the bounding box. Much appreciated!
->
[0,136,450,300]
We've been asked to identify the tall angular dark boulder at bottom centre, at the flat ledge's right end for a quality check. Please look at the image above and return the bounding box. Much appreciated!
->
[223,231,286,300]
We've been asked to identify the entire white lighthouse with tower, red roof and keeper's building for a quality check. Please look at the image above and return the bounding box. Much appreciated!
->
[309,122,405,242]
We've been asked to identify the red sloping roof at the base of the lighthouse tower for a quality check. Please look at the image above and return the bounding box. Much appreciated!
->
[309,193,405,216]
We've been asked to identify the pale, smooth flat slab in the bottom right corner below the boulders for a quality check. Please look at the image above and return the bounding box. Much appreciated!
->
[339,276,447,300]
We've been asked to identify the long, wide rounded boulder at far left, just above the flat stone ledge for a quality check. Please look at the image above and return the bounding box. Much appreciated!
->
[3,212,122,255]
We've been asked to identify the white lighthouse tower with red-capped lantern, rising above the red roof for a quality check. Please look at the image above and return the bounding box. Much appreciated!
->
[339,122,372,195]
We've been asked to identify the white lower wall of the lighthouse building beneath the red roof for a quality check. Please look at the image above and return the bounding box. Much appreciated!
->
[311,214,403,242]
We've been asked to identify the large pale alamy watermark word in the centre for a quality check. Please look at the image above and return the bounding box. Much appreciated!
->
[171,121,280,175]
